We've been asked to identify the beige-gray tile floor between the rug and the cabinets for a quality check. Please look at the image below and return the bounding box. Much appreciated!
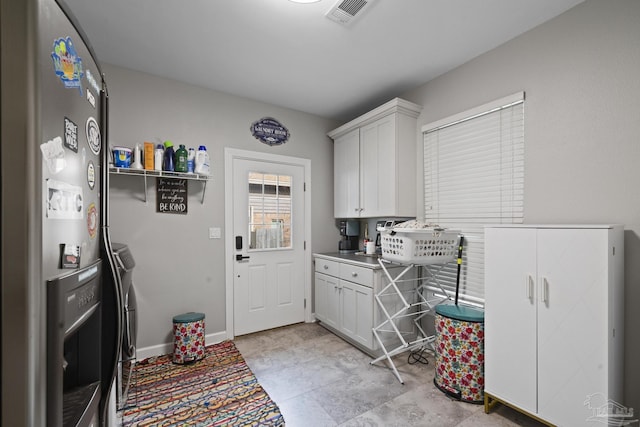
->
[235,323,542,427]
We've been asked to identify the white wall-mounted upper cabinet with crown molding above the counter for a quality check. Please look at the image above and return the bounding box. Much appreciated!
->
[329,98,422,218]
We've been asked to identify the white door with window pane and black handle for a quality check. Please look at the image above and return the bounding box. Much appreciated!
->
[232,158,305,335]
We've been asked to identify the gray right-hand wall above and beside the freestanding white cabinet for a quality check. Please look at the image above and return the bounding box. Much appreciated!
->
[401,0,640,418]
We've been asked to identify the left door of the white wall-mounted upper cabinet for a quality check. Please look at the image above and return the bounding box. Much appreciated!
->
[333,129,360,218]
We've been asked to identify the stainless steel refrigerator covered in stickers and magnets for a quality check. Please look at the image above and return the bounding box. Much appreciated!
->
[0,0,122,426]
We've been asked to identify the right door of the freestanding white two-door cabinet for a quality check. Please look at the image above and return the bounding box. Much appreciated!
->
[538,229,609,425]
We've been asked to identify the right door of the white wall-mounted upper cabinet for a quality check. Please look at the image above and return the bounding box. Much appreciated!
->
[360,114,397,217]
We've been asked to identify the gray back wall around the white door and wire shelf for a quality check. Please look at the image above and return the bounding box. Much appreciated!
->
[104,64,339,347]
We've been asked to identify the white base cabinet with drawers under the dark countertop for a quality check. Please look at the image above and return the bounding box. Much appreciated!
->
[315,257,412,356]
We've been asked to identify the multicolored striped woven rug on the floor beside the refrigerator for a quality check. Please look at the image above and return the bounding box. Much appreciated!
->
[122,341,285,427]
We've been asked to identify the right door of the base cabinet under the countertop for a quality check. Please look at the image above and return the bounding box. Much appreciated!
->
[340,280,373,349]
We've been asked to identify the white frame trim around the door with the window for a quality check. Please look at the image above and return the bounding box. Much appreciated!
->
[224,147,313,339]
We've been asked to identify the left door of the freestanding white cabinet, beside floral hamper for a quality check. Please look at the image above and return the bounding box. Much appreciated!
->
[485,228,537,413]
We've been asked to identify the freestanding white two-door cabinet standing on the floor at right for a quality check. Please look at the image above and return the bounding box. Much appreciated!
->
[485,226,624,426]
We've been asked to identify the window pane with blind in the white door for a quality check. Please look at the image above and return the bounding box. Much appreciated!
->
[249,172,291,249]
